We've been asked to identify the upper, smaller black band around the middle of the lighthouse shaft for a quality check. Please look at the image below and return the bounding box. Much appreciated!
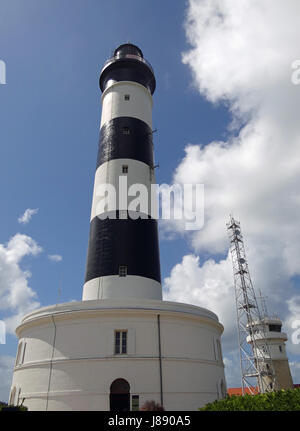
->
[97,117,153,168]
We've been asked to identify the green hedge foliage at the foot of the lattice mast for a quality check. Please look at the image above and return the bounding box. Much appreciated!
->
[199,388,300,411]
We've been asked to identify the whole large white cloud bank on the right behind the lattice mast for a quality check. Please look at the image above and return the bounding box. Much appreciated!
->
[165,0,300,384]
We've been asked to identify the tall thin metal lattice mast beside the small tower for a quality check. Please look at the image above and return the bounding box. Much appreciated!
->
[227,216,276,395]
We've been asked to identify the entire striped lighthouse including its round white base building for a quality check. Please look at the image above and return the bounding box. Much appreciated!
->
[9,43,226,411]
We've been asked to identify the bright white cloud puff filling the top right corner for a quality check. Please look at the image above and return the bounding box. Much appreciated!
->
[183,0,300,119]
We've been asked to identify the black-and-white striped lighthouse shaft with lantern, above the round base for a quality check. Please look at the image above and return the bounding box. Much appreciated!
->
[82,43,162,300]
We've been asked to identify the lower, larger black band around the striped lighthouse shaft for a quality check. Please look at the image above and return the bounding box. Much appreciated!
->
[85,212,161,283]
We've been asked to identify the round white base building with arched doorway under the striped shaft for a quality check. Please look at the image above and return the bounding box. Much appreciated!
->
[10,299,226,411]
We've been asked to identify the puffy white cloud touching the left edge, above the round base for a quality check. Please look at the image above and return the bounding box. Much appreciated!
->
[0,233,42,333]
